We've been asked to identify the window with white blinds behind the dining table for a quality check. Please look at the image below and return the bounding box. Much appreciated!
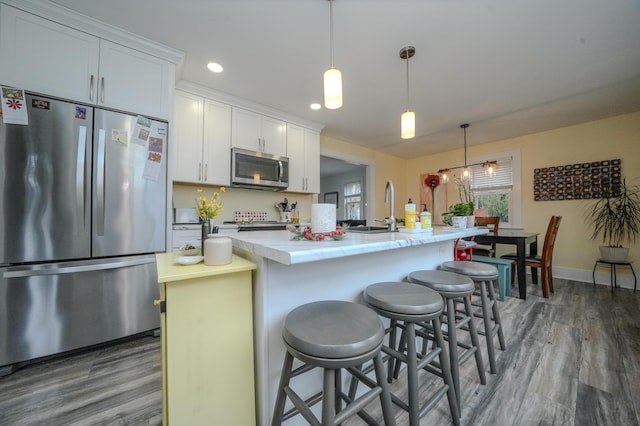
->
[471,151,522,227]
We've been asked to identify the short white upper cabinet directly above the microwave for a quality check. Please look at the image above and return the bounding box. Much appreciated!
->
[231,107,287,156]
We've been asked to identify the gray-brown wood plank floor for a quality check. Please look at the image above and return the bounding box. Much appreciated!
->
[0,279,640,426]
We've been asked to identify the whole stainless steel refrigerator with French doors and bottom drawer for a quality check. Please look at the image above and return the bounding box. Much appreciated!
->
[0,94,168,370]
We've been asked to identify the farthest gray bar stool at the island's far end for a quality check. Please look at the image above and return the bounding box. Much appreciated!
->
[442,261,506,374]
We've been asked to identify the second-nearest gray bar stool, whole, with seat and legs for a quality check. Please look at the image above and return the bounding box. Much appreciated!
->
[363,282,460,426]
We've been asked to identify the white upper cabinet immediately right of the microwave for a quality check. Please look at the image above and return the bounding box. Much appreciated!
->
[287,124,320,194]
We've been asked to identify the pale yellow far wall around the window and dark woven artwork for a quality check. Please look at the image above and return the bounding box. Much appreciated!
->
[404,112,640,270]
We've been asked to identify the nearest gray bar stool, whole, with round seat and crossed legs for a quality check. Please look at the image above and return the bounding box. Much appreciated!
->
[271,300,396,426]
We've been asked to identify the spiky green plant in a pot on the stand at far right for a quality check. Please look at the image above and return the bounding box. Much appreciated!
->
[586,179,640,262]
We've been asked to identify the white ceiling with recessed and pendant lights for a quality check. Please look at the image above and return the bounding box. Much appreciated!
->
[51,0,640,158]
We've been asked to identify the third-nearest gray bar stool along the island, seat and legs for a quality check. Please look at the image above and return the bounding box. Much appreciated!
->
[408,268,487,412]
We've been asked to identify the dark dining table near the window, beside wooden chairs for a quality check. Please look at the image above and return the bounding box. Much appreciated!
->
[475,229,540,299]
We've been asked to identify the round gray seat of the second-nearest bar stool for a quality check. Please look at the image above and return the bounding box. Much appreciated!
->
[363,282,444,321]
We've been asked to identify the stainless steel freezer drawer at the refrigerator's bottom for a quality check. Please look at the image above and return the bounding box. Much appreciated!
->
[0,255,160,366]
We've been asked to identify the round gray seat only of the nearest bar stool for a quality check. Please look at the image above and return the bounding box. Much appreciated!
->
[282,300,384,360]
